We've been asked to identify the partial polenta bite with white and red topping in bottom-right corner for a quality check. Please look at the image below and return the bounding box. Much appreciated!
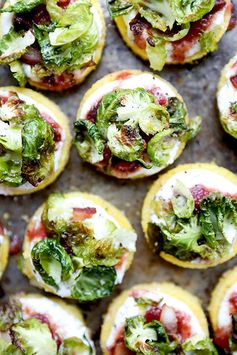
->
[209,267,237,354]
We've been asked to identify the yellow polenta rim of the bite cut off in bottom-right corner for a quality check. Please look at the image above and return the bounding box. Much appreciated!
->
[208,266,237,331]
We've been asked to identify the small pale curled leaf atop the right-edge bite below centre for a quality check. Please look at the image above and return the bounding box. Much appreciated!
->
[171,181,195,218]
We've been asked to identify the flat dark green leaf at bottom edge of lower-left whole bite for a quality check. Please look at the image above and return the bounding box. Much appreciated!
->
[72,266,116,301]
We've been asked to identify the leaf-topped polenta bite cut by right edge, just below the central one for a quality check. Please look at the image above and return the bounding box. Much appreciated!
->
[142,163,237,268]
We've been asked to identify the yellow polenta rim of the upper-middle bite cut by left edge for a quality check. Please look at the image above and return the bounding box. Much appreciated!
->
[0,86,72,195]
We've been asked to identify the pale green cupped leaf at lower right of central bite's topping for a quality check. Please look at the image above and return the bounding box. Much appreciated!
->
[147,129,177,166]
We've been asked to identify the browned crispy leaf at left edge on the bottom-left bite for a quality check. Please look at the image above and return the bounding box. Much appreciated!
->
[0,300,22,332]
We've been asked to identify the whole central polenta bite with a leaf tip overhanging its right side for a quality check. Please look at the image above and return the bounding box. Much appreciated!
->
[74,70,201,179]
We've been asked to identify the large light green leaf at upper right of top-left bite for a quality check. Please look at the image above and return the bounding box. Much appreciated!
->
[49,0,93,46]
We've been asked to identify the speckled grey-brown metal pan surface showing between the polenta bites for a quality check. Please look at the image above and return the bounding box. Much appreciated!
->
[0,0,237,354]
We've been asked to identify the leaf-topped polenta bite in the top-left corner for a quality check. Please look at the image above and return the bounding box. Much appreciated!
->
[0,0,105,91]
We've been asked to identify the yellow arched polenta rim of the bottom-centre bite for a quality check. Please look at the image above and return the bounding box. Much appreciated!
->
[100,283,209,355]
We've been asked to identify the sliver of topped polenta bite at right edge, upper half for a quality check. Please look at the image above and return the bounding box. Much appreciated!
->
[217,55,237,138]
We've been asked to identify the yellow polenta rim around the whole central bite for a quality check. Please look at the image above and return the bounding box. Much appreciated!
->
[77,69,189,179]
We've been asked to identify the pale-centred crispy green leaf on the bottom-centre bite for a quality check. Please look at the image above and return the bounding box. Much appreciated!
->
[125,316,177,355]
